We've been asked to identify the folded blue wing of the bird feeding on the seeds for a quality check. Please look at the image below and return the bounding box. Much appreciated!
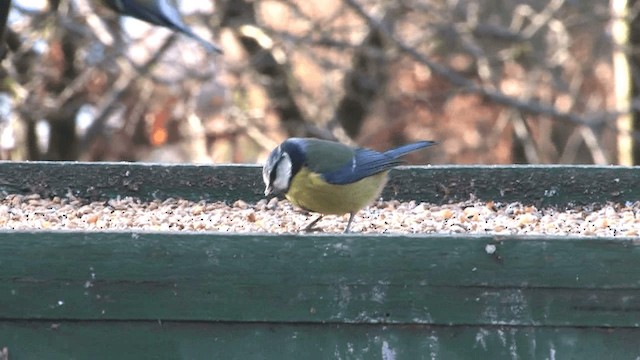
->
[322,149,402,185]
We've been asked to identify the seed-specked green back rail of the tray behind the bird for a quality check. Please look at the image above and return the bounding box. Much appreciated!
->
[0,162,640,205]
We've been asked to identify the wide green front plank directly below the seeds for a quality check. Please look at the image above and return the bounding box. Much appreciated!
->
[0,232,640,327]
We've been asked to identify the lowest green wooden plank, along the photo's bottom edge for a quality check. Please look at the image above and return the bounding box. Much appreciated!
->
[0,321,640,360]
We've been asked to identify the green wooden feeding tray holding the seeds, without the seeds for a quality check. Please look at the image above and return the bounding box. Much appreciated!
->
[0,163,640,360]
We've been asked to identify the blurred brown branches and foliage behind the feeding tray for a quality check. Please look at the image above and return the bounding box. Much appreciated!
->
[0,0,640,165]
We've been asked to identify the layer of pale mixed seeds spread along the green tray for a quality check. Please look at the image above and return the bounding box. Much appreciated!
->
[0,195,640,236]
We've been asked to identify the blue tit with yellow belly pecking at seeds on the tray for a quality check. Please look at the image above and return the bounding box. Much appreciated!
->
[262,138,435,233]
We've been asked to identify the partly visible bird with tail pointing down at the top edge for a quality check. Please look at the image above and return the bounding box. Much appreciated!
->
[102,0,222,54]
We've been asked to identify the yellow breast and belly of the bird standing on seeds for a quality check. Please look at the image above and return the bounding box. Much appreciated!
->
[286,167,388,215]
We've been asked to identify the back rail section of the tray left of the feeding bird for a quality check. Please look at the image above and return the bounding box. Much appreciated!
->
[0,161,264,201]
